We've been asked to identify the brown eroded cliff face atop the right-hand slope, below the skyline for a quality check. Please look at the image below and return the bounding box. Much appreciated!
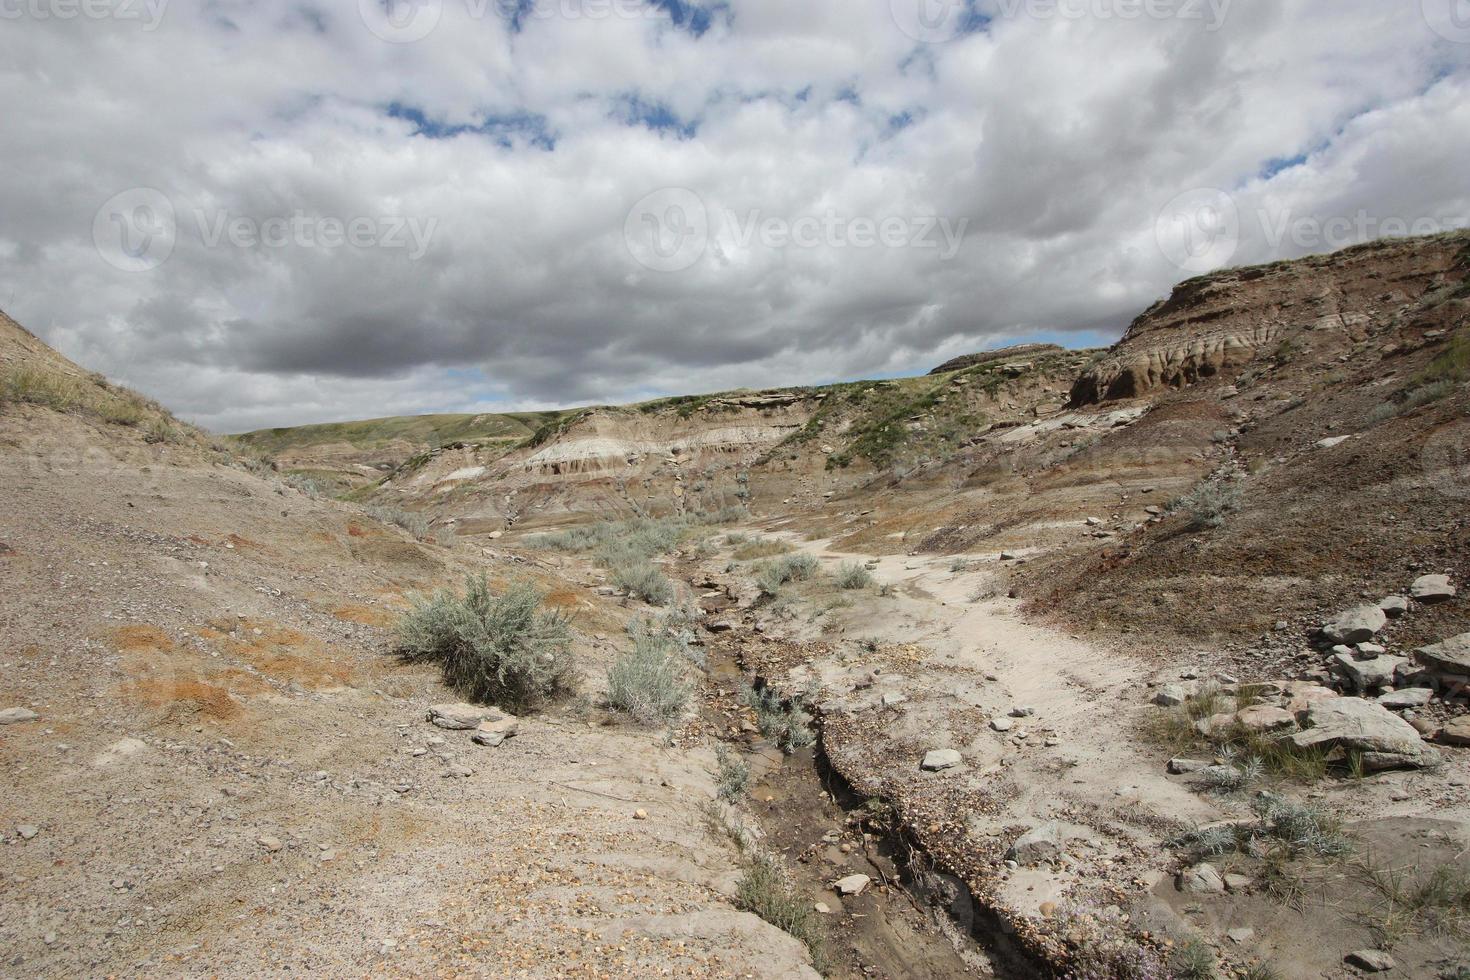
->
[1070,234,1470,407]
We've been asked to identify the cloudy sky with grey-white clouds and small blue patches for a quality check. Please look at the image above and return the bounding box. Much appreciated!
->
[0,0,1470,430]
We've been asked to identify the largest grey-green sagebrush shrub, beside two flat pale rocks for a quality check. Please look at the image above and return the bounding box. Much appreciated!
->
[395,574,576,711]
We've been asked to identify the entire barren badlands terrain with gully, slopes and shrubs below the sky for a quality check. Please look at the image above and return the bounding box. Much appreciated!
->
[0,226,1470,980]
